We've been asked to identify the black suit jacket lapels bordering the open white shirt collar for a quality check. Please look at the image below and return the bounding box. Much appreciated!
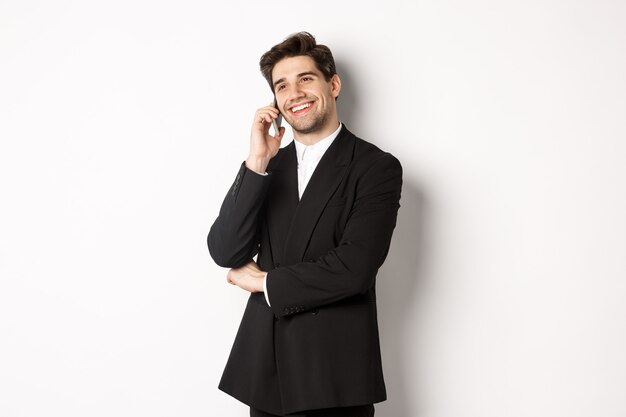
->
[282,125,355,265]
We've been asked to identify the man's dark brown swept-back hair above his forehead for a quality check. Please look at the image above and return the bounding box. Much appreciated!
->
[259,32,337,91]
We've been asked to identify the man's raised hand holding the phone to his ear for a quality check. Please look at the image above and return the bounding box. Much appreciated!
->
[246,105,285,174]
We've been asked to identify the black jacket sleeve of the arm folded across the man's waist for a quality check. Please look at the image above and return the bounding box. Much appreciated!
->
[266,154,402,318]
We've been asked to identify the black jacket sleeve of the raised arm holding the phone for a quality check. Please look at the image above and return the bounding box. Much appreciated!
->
[207,162,271,268]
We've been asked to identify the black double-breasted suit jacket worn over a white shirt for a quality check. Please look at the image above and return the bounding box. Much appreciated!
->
[208,125,402,415]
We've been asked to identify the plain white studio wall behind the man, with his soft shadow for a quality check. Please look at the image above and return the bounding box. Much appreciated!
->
[0,0,626,417]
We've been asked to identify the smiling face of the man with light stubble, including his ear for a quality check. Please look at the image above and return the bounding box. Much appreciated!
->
[272,55,341,134]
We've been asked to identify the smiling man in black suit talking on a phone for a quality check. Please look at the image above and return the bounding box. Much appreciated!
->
[208,32,402,417]
